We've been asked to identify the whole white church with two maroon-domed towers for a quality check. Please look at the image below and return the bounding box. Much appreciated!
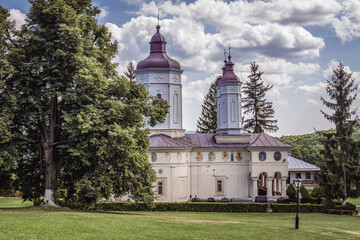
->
[135,25,292,202]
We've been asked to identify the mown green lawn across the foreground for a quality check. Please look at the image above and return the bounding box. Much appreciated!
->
[0,199,360,240]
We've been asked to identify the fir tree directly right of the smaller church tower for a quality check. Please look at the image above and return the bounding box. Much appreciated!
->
[242,62,279,133]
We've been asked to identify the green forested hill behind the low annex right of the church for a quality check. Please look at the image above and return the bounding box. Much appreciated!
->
[277,125,360,164]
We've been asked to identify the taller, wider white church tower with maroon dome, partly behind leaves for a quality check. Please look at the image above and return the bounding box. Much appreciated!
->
[135,24,185,137]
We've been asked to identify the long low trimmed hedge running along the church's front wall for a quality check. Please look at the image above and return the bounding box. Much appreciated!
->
[94,202,268,212]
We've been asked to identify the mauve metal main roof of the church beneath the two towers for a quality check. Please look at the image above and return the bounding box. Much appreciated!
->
[150,133,292,148]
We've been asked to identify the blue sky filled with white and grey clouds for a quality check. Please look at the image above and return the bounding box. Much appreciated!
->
[0,0,360,136]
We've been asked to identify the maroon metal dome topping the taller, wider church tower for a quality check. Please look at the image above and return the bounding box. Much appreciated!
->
[136,24,180,70]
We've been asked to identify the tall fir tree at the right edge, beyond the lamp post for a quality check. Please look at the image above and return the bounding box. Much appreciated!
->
[319,63,360,205]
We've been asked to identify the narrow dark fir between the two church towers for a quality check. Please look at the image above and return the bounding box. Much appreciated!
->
[196,76,221,133]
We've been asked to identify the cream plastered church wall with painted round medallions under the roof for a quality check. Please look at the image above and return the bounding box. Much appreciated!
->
[149,148,288,202]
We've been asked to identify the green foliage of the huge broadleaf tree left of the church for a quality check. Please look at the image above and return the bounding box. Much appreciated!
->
[0,0,168,206]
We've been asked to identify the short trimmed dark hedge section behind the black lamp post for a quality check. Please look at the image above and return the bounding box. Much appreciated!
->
[271,203,326,213]
